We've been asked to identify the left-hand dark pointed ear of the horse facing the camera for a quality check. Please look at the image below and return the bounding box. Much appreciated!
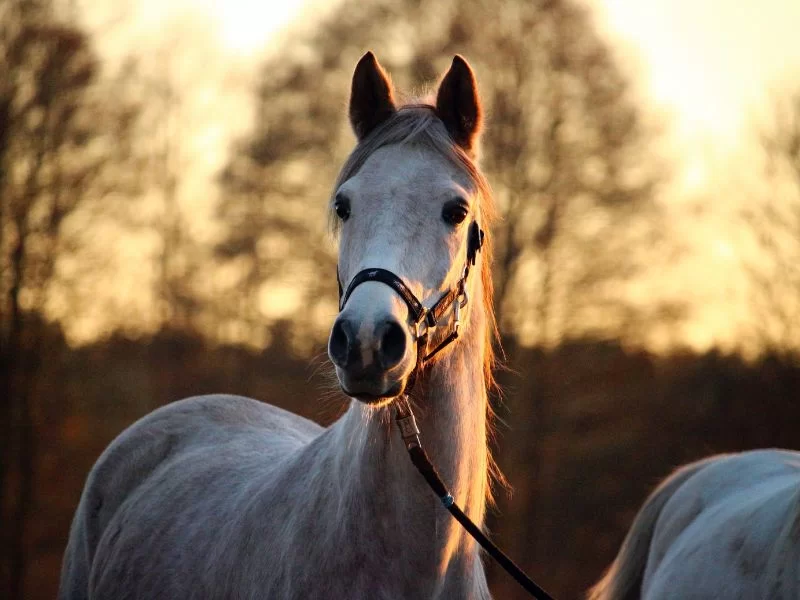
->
[350,52,396,141]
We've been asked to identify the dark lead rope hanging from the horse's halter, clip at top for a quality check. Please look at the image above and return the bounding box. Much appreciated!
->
[395,395,555,600]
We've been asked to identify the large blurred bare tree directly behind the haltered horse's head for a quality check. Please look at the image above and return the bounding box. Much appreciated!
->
[218,0,662,354]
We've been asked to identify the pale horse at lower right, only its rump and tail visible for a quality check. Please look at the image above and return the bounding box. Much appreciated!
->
[588,449,800,600]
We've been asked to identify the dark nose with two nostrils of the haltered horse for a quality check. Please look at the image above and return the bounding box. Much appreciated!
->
[328,317,407,376]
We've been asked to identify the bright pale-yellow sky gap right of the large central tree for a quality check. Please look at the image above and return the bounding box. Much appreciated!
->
[591,0,800,349]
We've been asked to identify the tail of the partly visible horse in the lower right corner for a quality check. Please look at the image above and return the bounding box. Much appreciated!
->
[587,460,708,600]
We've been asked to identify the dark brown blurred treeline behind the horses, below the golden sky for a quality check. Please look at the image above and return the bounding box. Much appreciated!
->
[17,328,800,600]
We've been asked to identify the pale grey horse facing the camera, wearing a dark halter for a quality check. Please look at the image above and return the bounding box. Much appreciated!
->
[59,53,496,600]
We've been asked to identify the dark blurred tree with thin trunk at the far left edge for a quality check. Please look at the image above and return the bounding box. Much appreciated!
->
[0,0,135,598]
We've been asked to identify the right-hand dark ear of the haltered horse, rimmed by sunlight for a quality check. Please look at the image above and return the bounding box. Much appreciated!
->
[436,55,483,154]
